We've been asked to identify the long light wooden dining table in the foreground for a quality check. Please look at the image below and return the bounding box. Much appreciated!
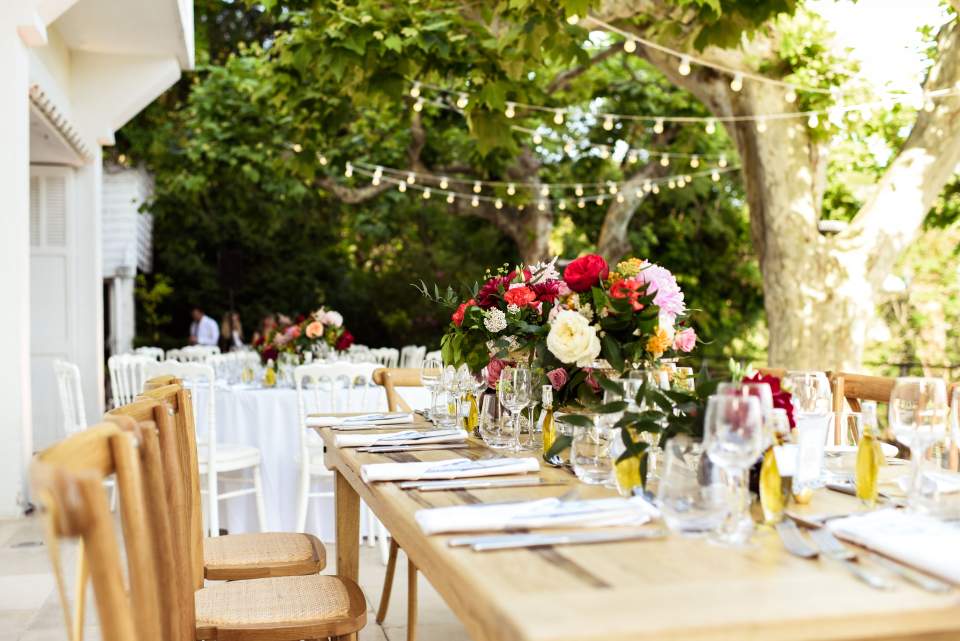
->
[318,425,960,641]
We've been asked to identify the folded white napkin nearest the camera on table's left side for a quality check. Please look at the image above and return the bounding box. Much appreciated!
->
[414,497,659,534]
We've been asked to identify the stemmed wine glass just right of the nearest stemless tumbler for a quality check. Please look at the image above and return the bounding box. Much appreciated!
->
[704,395,763,544]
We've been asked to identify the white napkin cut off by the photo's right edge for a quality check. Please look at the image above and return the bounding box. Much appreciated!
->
[827,510,960,584]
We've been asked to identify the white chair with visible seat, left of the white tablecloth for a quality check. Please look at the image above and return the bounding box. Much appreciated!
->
[147,361,267,536]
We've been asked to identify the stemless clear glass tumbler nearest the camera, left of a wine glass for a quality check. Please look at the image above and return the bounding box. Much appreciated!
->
[657,434,727,536]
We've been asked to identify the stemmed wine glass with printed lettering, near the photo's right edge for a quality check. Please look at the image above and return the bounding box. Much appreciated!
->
[889,376,949,512]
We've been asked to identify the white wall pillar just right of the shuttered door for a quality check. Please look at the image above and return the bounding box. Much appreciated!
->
[74,146,105,424]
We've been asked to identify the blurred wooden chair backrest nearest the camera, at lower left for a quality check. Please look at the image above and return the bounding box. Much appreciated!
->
[30,423,167,641]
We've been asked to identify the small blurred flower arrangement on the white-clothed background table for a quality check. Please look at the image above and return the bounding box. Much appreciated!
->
[253,307,353,363]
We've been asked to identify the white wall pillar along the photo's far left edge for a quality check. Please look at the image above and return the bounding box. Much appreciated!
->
[0,22,32,517]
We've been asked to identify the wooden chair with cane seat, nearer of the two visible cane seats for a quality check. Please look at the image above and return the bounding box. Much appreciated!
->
[105,399,366,641]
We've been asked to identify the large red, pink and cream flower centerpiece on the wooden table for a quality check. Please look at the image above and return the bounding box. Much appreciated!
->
[420,254,696,403]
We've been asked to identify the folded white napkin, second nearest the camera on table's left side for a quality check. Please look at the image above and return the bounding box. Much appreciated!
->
[360,457,540,483]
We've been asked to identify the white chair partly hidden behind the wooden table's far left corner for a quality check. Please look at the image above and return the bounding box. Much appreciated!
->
[293,363,388,563]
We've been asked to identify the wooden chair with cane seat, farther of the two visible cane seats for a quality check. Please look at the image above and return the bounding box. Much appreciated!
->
[129,377,327,585]
